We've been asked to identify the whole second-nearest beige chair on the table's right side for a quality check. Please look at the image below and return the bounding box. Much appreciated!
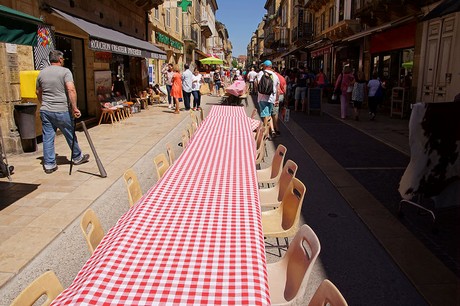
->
[267,224,320,305]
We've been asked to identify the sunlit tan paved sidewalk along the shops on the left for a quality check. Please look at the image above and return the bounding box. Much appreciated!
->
[0,104,190,287]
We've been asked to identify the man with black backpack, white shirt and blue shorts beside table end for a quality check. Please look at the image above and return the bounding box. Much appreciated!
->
[257,60,280,138]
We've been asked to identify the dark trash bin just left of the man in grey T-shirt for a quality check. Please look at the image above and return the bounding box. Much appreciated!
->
[14,102,37,152]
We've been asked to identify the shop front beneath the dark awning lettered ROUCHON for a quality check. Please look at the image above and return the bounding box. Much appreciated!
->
[49,8,166,117]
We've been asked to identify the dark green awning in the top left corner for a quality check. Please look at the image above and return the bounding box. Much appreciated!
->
[0,5,43,46]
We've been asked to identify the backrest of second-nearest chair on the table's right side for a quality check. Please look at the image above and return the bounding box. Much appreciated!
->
[282,224,321,301]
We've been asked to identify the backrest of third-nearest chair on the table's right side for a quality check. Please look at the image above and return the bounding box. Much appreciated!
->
[277,177,307,237]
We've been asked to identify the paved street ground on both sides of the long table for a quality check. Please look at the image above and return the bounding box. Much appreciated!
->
[0,97,459,305]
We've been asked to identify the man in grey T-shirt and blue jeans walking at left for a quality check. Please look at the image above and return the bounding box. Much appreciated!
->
[36,50,89,174]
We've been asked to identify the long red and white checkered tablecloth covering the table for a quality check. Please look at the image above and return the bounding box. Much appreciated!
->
[52,106,270,305]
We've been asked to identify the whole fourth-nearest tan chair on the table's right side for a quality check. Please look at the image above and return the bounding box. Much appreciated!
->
[259,160,298,207]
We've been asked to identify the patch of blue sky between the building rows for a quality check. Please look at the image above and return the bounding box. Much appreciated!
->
[216,0,267,57]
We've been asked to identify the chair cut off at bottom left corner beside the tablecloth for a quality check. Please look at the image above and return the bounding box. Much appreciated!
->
[10,271,64,306]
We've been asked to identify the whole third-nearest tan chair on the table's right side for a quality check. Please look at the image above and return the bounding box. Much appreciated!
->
[262,177,307,256]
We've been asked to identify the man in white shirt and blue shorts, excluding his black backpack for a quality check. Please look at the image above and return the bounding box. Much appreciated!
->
[257,60,280,138]
